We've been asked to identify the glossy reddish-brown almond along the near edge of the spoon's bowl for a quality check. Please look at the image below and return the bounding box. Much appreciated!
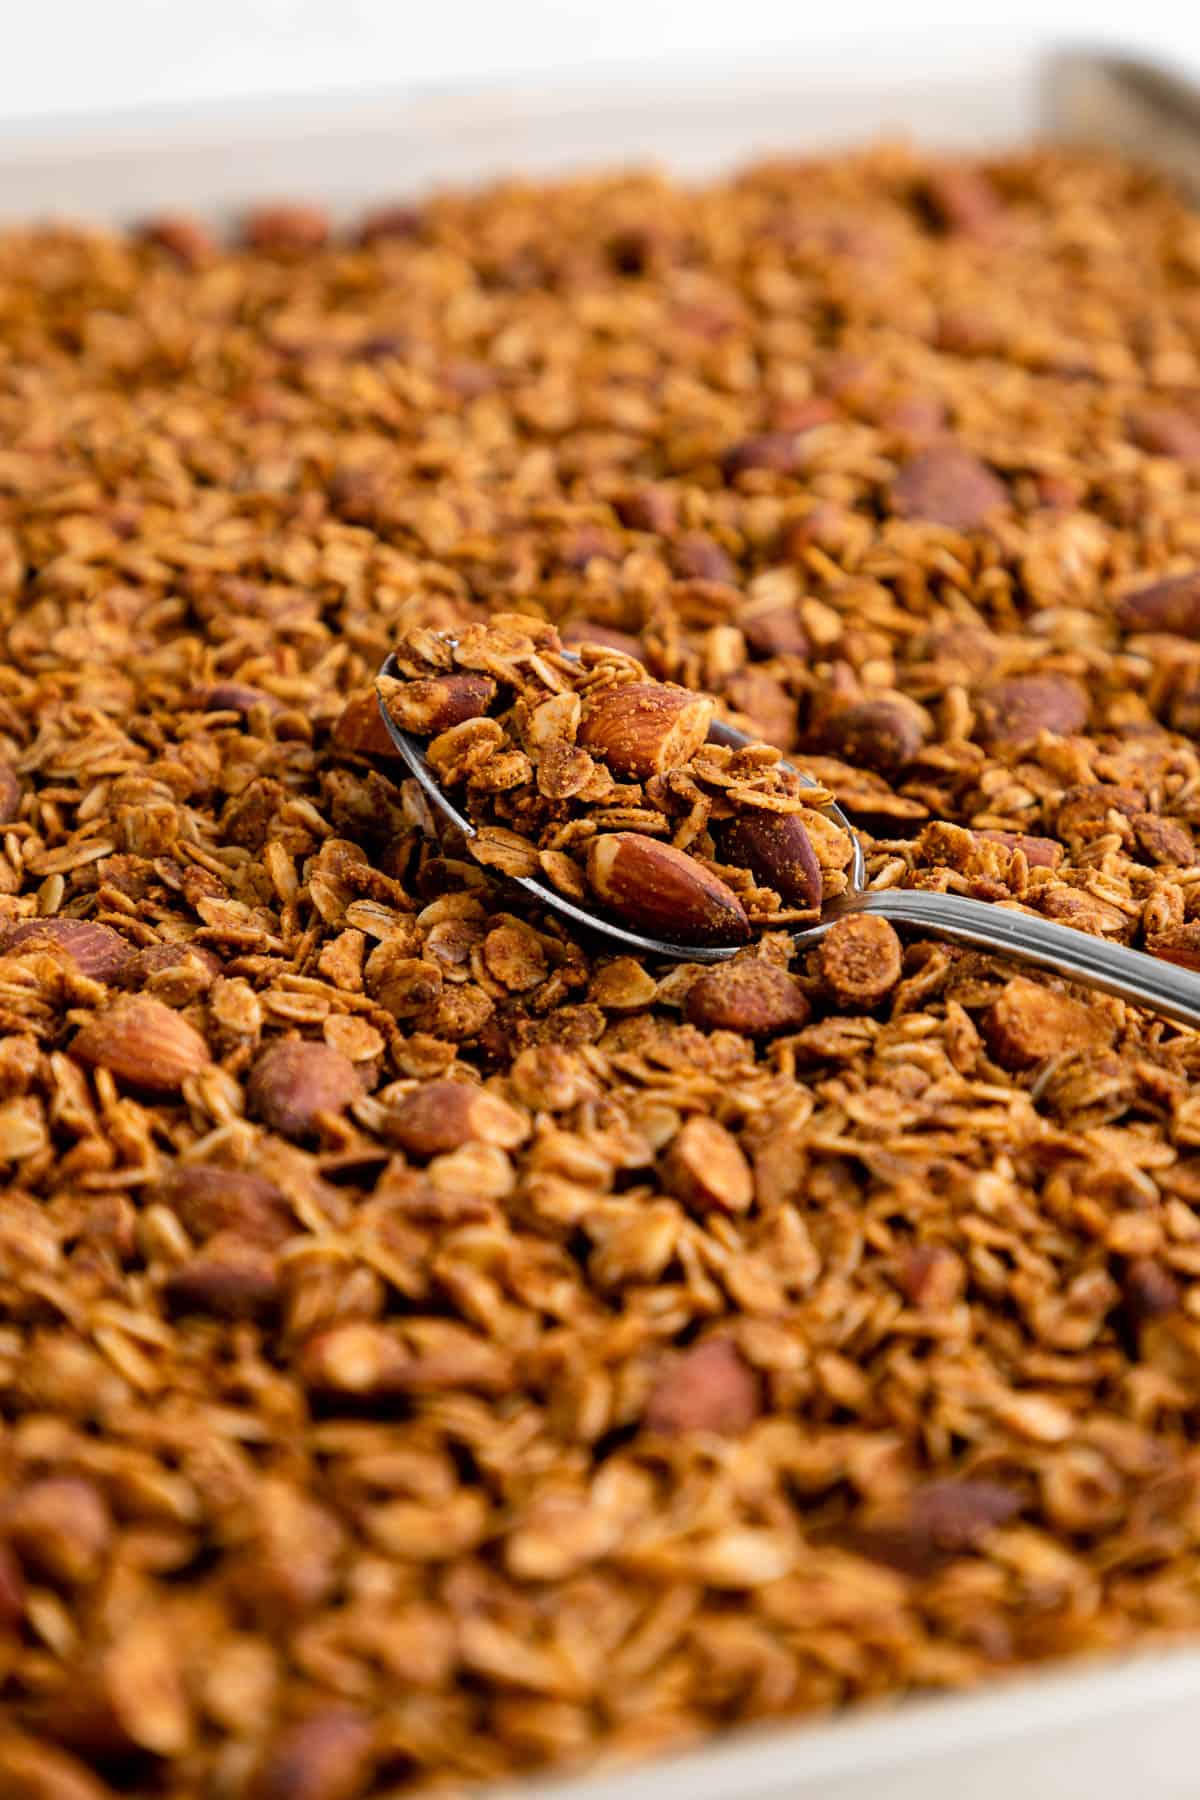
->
[588,832,750,945]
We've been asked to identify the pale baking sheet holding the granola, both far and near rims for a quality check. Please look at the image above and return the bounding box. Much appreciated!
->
[0,42,1200,1800]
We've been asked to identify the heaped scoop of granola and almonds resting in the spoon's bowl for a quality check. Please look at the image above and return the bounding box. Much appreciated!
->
[380,617,851,945]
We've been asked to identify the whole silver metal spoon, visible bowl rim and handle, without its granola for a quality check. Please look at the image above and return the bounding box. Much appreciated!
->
[380,657,1200,1026]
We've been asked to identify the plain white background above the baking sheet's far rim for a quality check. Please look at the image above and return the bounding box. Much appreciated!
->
[0,0,1200,126]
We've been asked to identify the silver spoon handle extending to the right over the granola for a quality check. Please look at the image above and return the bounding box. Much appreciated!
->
[795,887,1200,1028]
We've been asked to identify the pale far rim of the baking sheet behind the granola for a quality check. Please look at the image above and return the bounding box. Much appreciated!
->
[0,58,1038,221]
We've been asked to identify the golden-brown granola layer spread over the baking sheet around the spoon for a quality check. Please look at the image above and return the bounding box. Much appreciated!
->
[0,146,1200,1800]
